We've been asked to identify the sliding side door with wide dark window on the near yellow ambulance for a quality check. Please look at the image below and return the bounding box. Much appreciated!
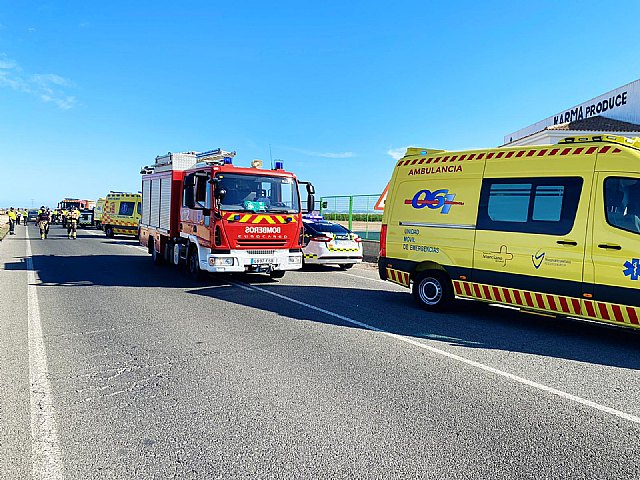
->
[473,175,592,314]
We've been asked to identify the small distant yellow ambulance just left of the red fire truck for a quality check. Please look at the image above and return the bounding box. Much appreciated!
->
[101,192,142,238]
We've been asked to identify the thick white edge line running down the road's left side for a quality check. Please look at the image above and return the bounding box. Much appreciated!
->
[26,230,64,480]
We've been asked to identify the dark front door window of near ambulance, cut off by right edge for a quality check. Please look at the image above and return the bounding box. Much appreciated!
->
[604,177,640,233]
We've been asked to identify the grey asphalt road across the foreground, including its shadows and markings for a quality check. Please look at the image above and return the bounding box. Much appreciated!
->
[0,226,640,480]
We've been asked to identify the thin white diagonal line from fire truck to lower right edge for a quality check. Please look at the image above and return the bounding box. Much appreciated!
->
[237,283,640,424]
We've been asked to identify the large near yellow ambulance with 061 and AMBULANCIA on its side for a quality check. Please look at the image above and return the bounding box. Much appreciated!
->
[378,135,640,328]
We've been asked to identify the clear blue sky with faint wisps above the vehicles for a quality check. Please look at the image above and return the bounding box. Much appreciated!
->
[0,0,640,206]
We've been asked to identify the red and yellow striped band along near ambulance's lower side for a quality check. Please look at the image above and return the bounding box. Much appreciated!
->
[452,280,640,328]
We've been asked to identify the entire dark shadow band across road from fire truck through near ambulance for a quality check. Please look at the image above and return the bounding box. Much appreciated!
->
[4,239,640,370]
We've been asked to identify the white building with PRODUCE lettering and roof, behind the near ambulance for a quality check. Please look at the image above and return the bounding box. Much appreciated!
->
[504,80,640,146]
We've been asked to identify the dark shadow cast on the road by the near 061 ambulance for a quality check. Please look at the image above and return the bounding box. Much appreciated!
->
[189,278,640,370]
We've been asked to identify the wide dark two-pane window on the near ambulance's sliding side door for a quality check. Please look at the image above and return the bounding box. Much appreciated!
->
[477,177,583,235]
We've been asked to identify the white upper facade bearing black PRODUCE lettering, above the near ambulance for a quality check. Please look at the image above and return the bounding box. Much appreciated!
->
[504,80,640,143]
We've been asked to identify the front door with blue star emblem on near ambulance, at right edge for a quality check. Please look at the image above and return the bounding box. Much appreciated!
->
[584,172,640,325]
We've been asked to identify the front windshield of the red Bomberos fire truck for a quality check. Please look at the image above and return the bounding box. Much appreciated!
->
[216,173,300,213]
